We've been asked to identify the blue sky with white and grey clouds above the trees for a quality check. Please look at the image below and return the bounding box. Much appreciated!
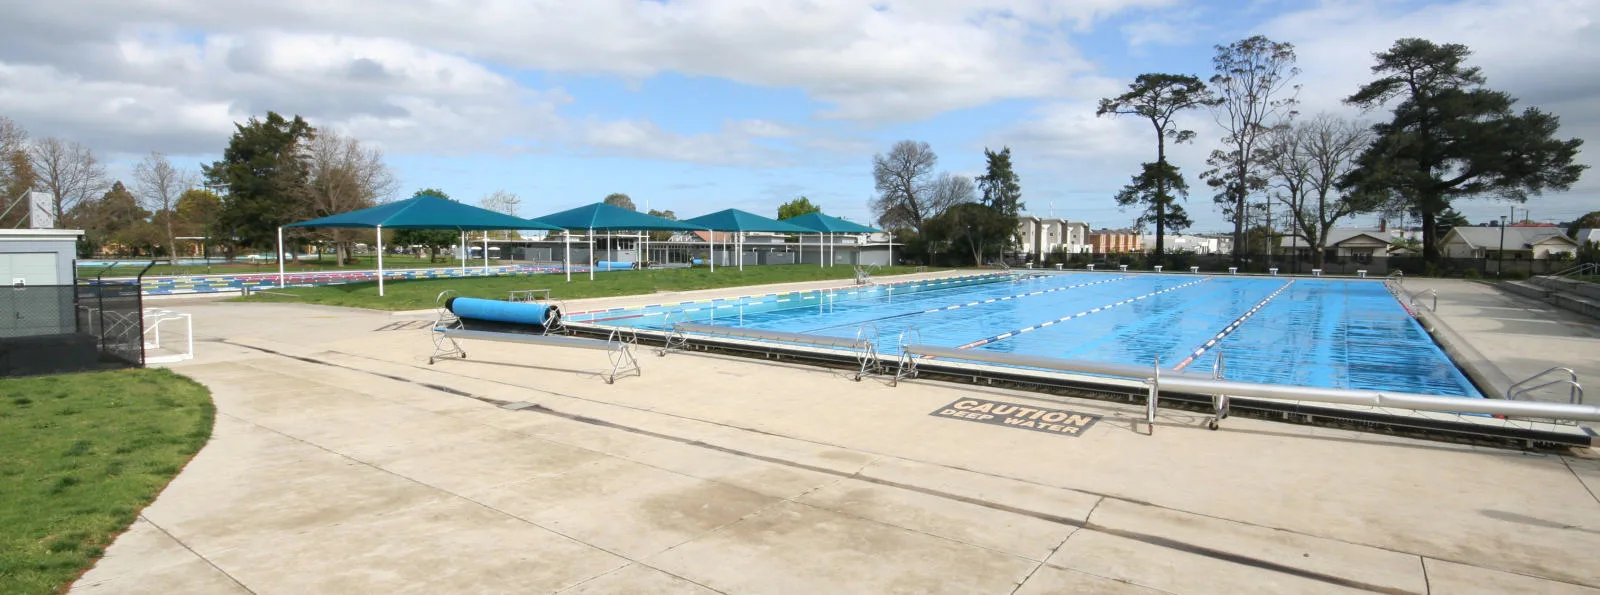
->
[0,0,1600,232]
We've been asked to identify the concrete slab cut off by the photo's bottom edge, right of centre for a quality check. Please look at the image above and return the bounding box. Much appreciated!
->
[645,502,1038,593]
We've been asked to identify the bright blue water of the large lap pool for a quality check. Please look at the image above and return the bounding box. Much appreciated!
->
[570,272,1482,397]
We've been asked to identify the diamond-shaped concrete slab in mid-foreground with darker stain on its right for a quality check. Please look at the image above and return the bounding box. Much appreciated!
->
[472,459,778,560]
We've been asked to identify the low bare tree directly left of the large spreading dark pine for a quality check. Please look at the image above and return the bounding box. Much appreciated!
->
[1261,114,1384,269]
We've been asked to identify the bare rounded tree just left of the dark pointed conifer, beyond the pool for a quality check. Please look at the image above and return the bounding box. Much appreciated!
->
[872,141,949,232]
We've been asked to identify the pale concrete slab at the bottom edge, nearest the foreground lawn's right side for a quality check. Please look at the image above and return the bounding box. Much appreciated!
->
[213,499,627,593]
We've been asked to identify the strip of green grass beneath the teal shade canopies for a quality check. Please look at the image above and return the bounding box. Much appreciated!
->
[235,264,933,310]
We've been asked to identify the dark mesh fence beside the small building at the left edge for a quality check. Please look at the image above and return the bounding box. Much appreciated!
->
[0,282,144,377]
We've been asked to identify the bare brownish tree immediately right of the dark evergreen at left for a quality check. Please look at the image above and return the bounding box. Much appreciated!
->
[304,130,398,262]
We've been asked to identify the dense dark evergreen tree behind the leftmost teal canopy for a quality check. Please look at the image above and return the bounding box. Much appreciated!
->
[202,112,315,254]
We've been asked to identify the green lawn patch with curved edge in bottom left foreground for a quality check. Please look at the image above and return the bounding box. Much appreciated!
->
[0,369,214,593]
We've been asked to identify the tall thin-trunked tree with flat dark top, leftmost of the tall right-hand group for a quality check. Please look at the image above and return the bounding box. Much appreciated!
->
[1094,74,1214,259]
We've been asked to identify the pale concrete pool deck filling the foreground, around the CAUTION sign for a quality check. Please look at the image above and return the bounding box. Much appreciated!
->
[74,276,1600,593]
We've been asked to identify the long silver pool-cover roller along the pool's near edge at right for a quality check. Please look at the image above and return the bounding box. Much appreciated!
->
[901,345,1600,422]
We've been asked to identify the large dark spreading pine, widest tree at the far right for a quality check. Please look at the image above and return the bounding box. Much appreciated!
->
[1342,38,1586,262]
